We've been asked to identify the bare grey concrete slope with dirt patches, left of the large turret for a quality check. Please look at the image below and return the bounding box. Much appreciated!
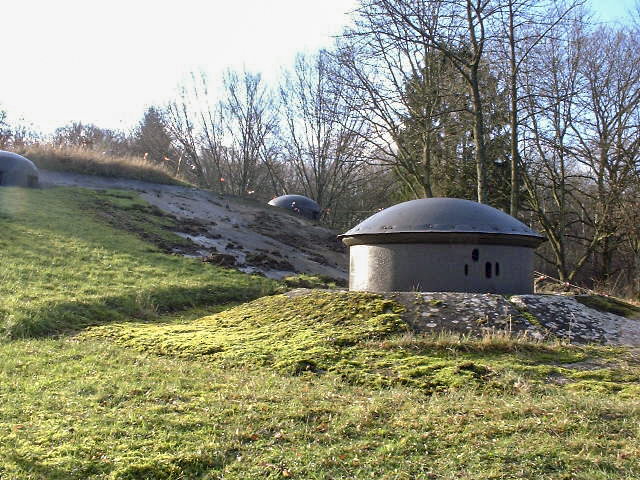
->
[40,170,347,280]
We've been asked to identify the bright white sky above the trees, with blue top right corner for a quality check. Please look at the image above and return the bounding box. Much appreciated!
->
[0,0,635,133]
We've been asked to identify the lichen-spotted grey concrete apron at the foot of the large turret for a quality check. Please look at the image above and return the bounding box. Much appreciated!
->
[384,292,640,347]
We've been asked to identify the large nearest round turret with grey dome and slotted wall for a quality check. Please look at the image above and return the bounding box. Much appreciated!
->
[340,198,545,294]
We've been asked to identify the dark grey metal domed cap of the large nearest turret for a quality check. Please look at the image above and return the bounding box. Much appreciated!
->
[338,198,545,247]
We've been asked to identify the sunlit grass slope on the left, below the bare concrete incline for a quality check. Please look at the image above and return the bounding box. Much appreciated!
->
[0,188,275,338]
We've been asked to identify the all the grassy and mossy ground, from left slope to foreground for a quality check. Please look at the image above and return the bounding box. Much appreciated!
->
[0,188,640,480]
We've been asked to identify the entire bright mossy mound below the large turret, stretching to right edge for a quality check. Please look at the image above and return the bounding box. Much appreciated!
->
[83,290,637,393]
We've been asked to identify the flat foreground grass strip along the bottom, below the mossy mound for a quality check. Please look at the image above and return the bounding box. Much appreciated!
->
[0,338,640,480]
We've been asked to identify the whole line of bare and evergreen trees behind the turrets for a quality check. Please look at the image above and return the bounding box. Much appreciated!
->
[0,0,640,295]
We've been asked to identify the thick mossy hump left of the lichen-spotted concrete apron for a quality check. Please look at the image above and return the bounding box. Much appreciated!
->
[88,292,407,373]
